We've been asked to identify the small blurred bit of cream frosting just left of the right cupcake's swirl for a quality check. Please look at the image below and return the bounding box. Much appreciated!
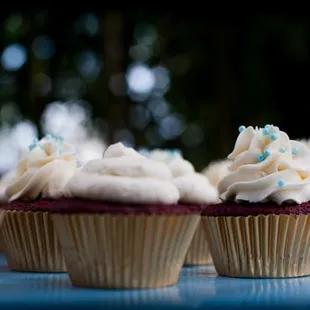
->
[201,159,231,188]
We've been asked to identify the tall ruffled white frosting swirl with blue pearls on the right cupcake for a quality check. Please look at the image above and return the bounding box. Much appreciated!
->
[218,125,310,205]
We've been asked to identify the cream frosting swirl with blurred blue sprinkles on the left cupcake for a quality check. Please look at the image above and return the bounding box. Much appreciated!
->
[6,137,77,201]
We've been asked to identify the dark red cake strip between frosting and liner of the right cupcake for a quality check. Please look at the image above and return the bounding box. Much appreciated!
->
[201,202,310,216]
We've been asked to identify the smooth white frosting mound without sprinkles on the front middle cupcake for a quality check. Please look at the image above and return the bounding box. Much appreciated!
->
[66,143,179,204]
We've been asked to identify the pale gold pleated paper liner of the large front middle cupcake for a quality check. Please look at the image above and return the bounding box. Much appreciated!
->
[52,214,200,288]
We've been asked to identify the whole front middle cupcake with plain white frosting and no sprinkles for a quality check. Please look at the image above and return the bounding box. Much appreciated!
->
[50,143,201,288]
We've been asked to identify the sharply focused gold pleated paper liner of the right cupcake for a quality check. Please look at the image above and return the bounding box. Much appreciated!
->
[202,215,310,278]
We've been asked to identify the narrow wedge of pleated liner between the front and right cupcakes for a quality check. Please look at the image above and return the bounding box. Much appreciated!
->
[184,222,213,265]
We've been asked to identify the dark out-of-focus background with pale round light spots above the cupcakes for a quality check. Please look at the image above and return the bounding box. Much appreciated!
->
[0,9,310,172]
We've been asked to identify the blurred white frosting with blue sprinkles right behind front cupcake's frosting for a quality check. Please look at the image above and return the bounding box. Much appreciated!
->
[144,150,218,204]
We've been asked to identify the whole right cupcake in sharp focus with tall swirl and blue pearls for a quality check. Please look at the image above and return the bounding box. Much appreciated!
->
[202,125,310,278]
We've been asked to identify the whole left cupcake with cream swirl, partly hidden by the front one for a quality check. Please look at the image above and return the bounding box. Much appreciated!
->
[2,136,77,272]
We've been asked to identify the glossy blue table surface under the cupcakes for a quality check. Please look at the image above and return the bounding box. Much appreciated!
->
[0,254,310,310]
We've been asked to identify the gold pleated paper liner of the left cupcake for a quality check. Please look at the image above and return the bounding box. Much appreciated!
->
[2,211,67,272]
